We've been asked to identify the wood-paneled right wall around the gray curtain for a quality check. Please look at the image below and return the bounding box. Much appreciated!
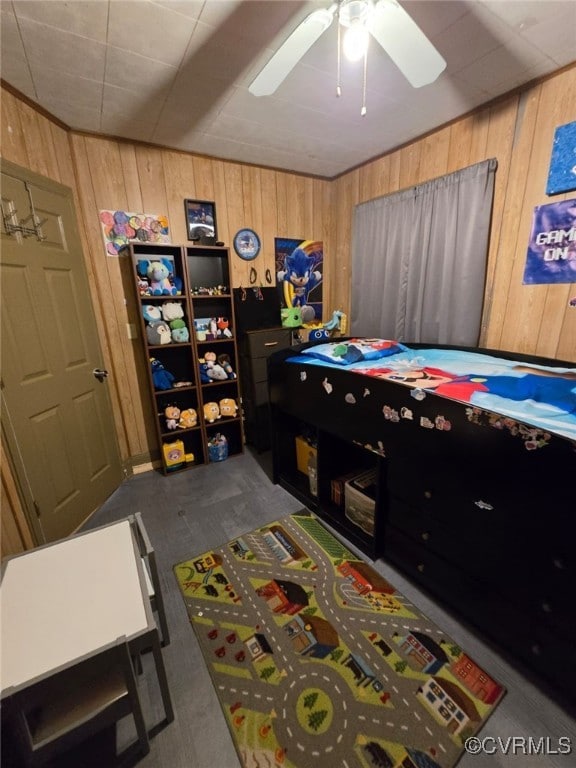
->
[331,67,576,361]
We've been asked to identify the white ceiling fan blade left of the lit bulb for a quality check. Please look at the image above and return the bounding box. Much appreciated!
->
[248,5,337,96]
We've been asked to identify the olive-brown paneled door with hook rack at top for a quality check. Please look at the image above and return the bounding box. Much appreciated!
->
[0,161,122,541]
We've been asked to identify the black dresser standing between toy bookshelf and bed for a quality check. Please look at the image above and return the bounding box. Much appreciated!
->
[238,326,292,452]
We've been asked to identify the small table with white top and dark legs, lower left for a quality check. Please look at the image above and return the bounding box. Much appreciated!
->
[0,520,174,722]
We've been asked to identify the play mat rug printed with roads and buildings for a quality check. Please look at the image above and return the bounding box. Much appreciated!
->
[174,510,504,768]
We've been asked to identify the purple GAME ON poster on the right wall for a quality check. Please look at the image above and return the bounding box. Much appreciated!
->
[522,200,576,285]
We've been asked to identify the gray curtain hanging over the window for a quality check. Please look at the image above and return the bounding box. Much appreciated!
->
[350,159,497,346]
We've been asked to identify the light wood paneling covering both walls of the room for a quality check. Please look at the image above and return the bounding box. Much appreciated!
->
[0,66,576,548]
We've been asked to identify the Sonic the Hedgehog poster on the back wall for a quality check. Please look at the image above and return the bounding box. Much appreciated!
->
[274,237,324,323]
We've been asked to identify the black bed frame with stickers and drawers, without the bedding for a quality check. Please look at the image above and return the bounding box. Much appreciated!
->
[268,342,576,708]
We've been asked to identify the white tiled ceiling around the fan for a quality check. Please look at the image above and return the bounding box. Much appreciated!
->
[0,0,576,178]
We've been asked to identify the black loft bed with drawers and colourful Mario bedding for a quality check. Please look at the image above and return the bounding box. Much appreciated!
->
[268,338,576,703]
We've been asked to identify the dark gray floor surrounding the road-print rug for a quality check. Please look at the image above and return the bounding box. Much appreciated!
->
[12,450,576,768]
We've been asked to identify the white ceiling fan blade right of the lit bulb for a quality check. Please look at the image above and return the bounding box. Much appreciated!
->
[369,0,446,88]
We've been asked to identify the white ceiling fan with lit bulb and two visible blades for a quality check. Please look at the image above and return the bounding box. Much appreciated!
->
[248,0,446,96]
